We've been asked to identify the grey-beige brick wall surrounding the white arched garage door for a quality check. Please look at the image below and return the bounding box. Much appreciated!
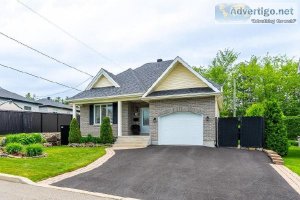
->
[149,96,216,147]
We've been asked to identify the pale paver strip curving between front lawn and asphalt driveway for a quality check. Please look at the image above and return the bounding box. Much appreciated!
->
[37,147,115,185]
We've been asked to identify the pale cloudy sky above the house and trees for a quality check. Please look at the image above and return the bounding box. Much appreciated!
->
[0,0,300,98]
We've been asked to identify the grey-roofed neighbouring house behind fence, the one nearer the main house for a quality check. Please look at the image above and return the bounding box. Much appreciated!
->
[36,97,72,114]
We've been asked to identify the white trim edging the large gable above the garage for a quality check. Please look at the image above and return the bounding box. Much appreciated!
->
[143,56,220,98]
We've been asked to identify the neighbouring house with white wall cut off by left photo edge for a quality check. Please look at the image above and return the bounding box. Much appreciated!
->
[0,87,40,112]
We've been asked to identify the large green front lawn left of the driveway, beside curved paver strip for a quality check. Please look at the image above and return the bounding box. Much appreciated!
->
[0,146,105,181]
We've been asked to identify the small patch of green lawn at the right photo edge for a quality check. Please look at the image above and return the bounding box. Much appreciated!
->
[283,146,300,175]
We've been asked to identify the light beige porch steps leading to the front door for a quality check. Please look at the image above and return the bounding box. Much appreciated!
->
[113,136,150,148]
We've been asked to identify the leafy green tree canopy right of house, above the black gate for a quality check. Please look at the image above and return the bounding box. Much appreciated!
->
[194,49,300,116]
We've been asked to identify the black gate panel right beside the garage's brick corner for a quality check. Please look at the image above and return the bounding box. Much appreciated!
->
[218,117,239,147]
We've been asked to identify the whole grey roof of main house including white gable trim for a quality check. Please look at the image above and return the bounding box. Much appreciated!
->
[68,57,220,102]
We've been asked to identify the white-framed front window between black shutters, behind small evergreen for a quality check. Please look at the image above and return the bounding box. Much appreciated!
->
[94,104,113,124]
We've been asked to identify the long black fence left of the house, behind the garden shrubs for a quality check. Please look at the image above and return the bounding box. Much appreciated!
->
[0,111,72,134]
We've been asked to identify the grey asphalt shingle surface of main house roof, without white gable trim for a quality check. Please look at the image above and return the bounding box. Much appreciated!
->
[68,60,220,100]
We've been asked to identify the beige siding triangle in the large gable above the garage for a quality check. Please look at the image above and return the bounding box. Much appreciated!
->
[154,63,208,91]
